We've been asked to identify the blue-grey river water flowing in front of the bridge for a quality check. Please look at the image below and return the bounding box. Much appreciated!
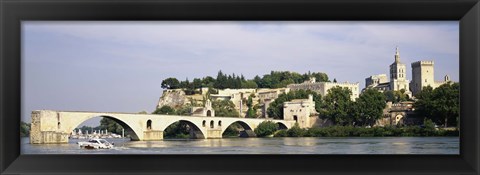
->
[21,137,460,154]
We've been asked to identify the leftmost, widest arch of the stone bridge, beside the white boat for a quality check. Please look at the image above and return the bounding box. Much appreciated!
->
[68,115,143,140]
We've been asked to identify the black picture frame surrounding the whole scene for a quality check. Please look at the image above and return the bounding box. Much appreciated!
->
[0,0,480,174]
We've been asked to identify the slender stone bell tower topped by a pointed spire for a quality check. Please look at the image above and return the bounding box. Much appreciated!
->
[390,47,409,91]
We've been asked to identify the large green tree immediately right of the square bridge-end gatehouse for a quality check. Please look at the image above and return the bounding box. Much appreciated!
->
[320,86,354,125]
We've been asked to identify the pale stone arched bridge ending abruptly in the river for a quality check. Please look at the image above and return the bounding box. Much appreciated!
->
[30,110,295,144]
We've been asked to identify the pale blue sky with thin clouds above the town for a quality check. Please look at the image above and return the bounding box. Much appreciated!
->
[21,21,459,126]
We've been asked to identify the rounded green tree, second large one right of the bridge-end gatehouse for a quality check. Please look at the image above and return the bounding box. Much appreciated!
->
[352,89,386,126]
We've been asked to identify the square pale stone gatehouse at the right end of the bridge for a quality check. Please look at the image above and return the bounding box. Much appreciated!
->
[283,94,318,128]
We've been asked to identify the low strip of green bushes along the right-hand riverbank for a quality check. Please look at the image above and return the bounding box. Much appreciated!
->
[274,126,459,137]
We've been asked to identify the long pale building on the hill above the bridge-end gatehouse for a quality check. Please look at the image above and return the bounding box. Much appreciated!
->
[287,78,360,101]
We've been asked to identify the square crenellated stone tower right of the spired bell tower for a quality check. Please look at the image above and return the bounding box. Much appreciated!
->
[410,61,435,95]
